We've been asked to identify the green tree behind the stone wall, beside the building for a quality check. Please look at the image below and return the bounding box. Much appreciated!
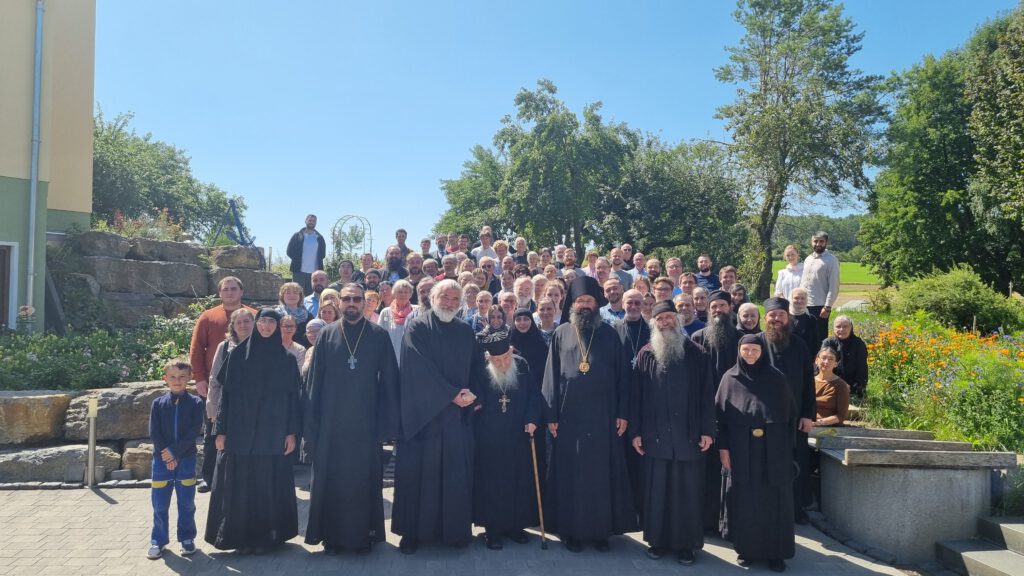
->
[92,110,245,240]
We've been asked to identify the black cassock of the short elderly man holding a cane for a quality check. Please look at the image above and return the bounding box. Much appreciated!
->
[473,356,544,535]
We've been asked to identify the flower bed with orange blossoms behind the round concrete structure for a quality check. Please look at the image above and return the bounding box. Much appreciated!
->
[858,315,1024,453]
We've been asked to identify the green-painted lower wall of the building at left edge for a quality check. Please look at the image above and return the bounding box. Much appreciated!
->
[0,172,48,330]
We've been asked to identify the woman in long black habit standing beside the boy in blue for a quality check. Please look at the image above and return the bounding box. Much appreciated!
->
[206,307,301,551]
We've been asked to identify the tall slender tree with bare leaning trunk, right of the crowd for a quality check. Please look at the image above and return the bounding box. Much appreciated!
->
[715,0,885,297]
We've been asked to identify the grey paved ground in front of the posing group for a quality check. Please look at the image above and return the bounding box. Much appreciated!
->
[0,469,904,576]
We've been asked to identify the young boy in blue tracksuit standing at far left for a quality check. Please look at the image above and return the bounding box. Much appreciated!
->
[146,360,204,560]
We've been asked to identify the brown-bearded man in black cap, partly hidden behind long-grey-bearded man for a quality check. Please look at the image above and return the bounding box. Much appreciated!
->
[693,290,739,534]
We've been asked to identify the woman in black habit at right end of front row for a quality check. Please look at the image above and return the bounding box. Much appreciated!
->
[715,335,797,572]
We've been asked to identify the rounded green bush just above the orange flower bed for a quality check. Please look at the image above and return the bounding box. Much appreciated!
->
[892,266,1024,333]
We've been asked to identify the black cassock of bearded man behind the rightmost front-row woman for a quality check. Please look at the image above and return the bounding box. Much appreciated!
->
[761,334,817,515]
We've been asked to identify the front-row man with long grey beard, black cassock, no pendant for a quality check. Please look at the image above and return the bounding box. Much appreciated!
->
[630,300,718,565]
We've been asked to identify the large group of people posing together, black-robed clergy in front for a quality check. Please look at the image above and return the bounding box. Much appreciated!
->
[151,215,866,571]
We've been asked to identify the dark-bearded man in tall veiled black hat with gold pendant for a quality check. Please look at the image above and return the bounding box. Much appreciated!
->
[544,276,637,551]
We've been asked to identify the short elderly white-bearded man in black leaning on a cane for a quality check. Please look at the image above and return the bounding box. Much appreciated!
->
[473,331,541,550]
